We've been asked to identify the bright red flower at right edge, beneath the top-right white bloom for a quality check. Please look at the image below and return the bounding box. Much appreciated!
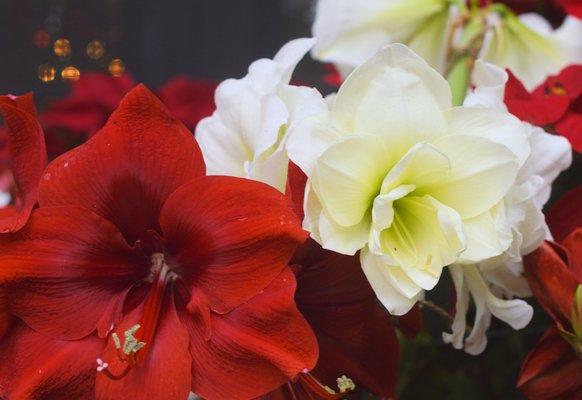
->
[505,65,582,152]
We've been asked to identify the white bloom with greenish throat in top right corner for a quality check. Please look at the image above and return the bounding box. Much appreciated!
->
[480,13,582,90]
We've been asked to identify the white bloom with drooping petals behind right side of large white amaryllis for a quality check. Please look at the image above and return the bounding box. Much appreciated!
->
[443,62,572,354]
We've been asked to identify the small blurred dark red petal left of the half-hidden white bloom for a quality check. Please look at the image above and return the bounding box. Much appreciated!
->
[158,76,218,129]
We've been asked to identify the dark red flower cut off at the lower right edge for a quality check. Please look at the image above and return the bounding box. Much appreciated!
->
[518,228,582,400]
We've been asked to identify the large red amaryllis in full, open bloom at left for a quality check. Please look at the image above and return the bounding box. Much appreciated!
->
[0,86,317,400]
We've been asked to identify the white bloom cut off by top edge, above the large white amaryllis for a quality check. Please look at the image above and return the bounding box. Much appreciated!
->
[313,0,454,76]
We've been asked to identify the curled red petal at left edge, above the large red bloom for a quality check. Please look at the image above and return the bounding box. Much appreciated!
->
[0,94,46,232]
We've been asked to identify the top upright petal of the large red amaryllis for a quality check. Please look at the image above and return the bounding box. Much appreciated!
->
[39,86,205,243]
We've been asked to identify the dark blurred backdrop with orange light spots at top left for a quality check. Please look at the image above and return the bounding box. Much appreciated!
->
[0,0,316,97]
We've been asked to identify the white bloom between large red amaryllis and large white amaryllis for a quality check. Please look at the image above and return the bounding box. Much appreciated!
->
[196,39,327,191]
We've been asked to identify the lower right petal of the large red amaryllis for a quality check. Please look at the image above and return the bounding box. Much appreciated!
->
[181,268,317,400]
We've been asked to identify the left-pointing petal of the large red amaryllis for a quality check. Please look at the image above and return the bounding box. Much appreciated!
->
[0,207,149,339]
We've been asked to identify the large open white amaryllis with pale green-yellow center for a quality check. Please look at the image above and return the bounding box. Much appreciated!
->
[287,44,530,314]
